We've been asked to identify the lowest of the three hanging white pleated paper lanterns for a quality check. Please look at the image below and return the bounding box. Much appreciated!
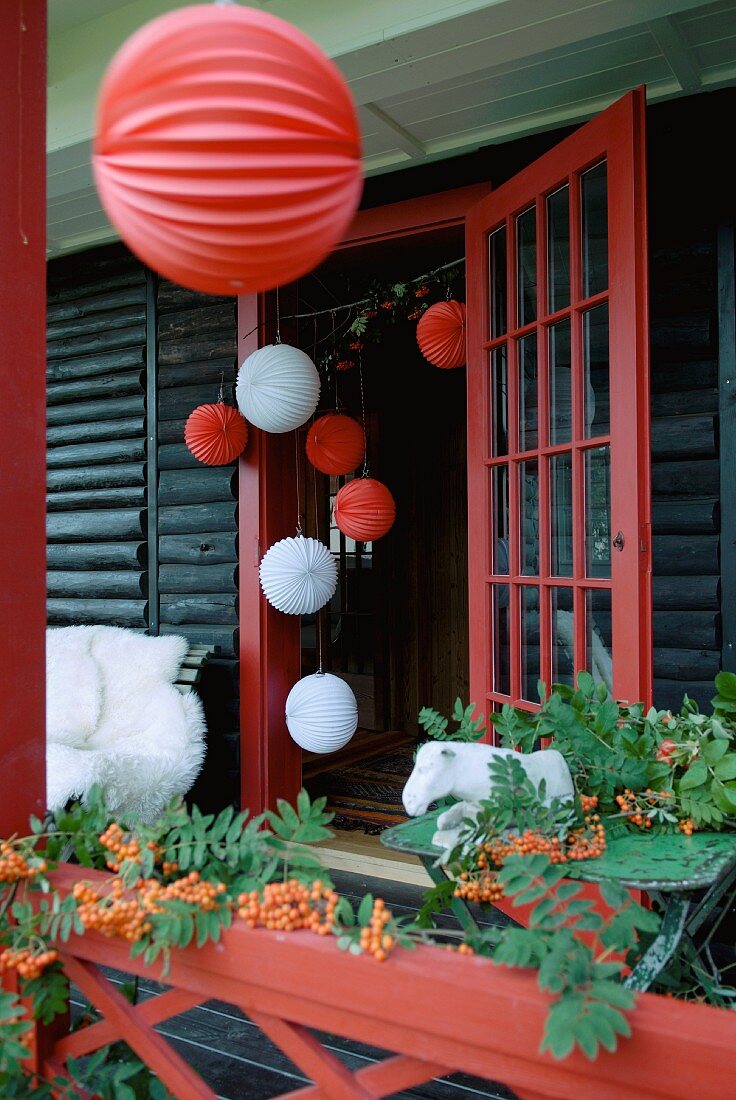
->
[286,672,358,752]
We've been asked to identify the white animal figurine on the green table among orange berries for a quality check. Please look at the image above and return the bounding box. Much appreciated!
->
[403,741,574,856]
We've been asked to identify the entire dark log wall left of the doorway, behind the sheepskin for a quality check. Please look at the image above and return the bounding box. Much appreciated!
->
[47,253,239,809]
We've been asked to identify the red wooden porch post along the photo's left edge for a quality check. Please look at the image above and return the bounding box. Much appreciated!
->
[0,0,46,836]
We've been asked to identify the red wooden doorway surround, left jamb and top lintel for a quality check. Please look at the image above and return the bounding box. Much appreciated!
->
[238,184,488,813]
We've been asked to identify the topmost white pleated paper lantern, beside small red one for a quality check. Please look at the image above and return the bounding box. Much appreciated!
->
[235,343,320,432]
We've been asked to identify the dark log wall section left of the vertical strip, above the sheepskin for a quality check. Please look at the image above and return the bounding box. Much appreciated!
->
[47,245,149,630]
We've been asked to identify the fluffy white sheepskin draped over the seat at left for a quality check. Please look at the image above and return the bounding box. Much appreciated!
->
[46,626,206,822]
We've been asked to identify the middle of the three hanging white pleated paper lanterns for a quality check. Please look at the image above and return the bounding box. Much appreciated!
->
[260,535,338,615]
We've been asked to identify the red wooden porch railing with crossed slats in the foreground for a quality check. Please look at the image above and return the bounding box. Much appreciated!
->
[28,867,736,1100]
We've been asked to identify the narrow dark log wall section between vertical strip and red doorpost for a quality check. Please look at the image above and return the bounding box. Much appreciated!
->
[157,282,240,809]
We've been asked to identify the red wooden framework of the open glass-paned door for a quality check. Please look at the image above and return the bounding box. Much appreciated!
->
[466,89,651,711]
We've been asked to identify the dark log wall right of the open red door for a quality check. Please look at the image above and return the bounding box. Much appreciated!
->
[648,95,721,708]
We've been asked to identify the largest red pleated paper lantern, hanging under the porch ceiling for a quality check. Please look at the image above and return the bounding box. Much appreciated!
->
[92,4,362,295]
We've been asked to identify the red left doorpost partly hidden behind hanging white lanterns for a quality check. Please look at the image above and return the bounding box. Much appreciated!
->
[238,295,301,813]
